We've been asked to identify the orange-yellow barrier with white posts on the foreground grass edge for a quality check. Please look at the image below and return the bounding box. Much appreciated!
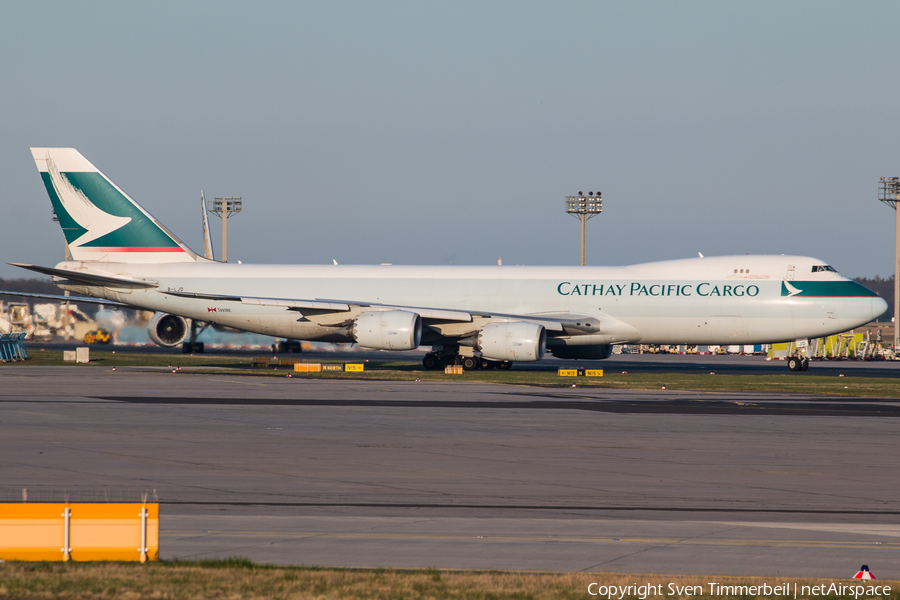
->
[0,503,159,562]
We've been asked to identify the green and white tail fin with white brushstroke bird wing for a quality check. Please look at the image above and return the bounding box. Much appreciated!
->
[31,148,197,263]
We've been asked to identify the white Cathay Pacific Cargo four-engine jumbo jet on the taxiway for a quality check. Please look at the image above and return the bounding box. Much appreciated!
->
[1,148,887,370]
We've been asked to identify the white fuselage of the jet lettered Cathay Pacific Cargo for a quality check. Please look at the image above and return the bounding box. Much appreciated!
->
[57,256,887,344]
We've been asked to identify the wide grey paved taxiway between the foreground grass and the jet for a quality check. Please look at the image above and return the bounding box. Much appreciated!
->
[0,366,900,579]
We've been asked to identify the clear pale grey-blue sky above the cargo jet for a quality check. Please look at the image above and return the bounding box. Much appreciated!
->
[0,1,900,277]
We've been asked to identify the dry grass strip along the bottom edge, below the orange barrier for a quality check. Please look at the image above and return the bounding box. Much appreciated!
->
[0,558,900,600]
